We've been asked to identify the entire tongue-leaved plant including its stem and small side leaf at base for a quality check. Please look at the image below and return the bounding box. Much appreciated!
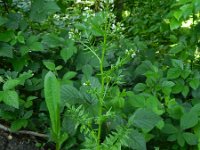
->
[44,72,68,150]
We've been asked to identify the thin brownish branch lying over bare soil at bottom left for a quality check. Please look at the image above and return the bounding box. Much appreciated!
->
[0,124,49,138]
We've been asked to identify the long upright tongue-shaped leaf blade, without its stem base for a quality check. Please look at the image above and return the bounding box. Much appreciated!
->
[44,71,60,136]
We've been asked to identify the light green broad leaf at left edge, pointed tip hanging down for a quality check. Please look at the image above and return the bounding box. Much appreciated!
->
[3,90,19,108]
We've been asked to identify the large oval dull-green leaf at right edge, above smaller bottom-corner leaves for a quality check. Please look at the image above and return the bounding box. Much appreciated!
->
[180,111,198,130]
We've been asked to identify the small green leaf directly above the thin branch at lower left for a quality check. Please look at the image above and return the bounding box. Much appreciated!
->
[11,119,28,132]
